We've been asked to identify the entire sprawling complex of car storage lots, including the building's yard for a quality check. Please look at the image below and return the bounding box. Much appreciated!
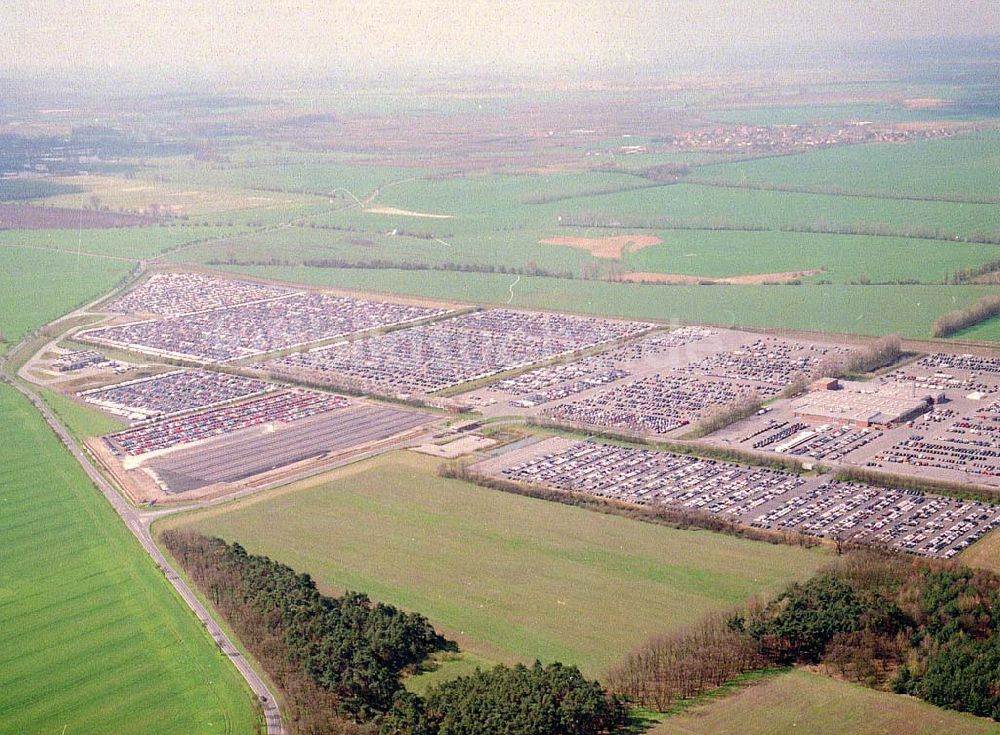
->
[52,273,1000,558]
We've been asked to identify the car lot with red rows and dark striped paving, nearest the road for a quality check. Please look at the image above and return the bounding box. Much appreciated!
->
[88,382,436,500]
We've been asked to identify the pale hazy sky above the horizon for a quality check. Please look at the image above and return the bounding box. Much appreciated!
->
[0,0,1000,80]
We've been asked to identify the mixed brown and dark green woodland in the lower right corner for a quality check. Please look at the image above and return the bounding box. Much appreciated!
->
[608,550,1000,720]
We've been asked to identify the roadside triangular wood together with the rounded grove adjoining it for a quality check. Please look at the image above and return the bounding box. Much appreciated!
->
[166,529,627,735]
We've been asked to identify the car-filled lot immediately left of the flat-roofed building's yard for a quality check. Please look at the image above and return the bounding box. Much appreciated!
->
[465,327,850,438]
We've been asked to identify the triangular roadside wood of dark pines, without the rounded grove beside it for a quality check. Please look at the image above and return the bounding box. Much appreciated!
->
[161,530,456,733]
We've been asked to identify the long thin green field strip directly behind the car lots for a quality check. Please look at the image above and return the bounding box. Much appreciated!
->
[209,266,995,338]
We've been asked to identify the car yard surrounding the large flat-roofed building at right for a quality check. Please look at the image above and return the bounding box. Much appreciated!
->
[708,353,1000,487]
